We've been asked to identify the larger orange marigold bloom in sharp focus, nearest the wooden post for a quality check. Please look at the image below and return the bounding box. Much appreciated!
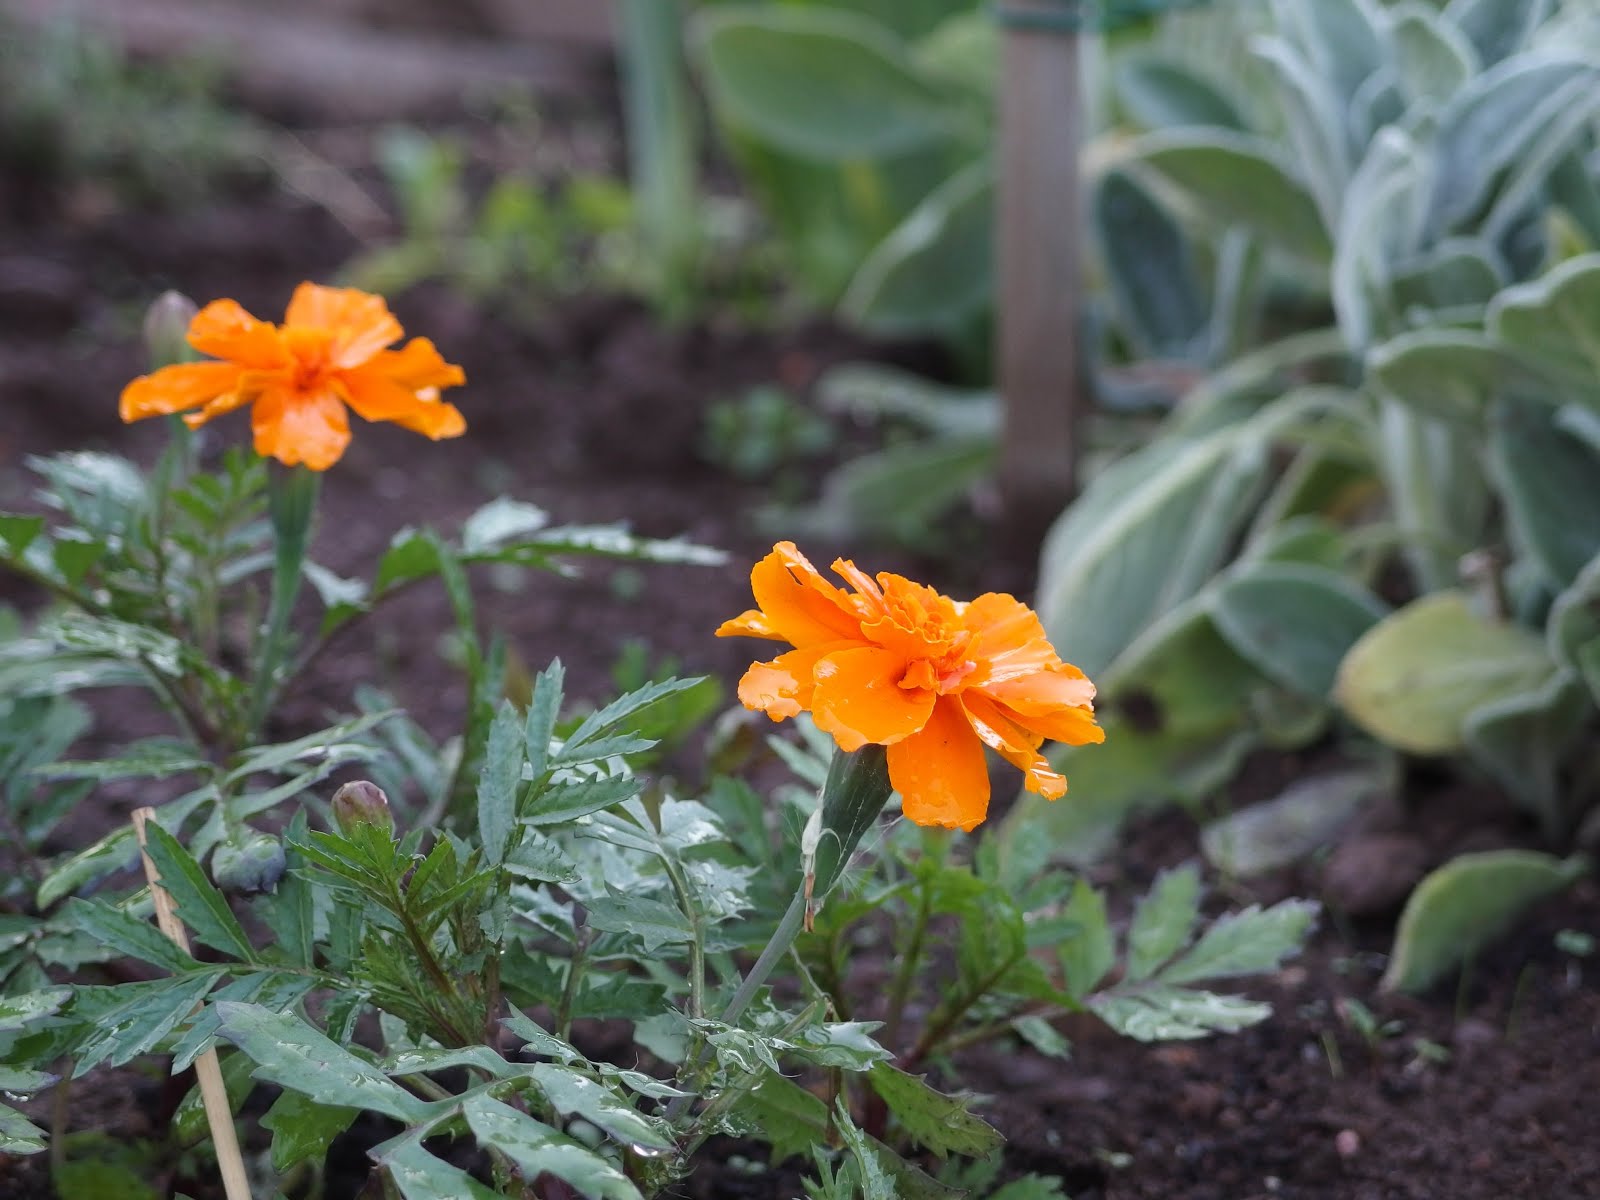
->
[717,542,1106,829]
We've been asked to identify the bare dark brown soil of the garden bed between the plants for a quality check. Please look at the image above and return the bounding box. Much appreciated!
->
[0,63,1600,1200]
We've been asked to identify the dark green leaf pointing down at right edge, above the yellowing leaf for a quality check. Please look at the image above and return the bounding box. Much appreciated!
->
[1488,404,1600,589]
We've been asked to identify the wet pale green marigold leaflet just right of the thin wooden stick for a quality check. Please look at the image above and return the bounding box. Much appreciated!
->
[216,1000,430,1123]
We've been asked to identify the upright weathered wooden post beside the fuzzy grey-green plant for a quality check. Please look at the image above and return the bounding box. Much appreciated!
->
[997,0,1083,546]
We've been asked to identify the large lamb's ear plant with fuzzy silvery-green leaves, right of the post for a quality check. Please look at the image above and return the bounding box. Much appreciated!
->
[1016,0,1600,989]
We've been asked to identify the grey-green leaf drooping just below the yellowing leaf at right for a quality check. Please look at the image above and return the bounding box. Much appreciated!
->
[1462,670,1595,838]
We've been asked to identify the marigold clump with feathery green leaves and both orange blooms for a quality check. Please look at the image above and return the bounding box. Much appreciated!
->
[0,285,1312,1200]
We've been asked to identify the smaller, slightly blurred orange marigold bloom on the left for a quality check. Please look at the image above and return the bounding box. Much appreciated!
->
[122,283,467,470]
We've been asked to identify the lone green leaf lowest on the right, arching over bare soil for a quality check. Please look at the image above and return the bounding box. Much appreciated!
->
[1382,850,1589,992]
